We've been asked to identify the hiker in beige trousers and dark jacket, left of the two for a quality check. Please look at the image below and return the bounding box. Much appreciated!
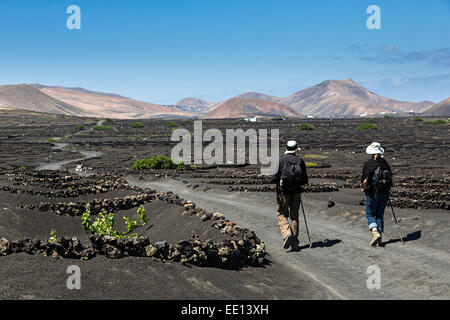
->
[272,141,308,251]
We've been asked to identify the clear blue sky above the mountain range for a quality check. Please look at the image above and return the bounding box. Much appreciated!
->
[0,0,450,104]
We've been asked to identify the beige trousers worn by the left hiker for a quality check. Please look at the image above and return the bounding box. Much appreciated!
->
[278,193,302,240]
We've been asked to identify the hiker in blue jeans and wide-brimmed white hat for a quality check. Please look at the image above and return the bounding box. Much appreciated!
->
[361,142,392,246]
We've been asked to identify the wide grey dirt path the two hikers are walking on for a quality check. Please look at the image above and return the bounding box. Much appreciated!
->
[128,177,450,299]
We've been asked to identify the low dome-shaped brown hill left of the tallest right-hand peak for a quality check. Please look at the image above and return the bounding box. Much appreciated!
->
[203,98,302,119]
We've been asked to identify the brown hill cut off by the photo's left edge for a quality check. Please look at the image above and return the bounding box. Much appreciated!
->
[0,84,89,116]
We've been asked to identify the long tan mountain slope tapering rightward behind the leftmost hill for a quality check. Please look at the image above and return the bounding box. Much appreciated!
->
[34,85,195,119]
